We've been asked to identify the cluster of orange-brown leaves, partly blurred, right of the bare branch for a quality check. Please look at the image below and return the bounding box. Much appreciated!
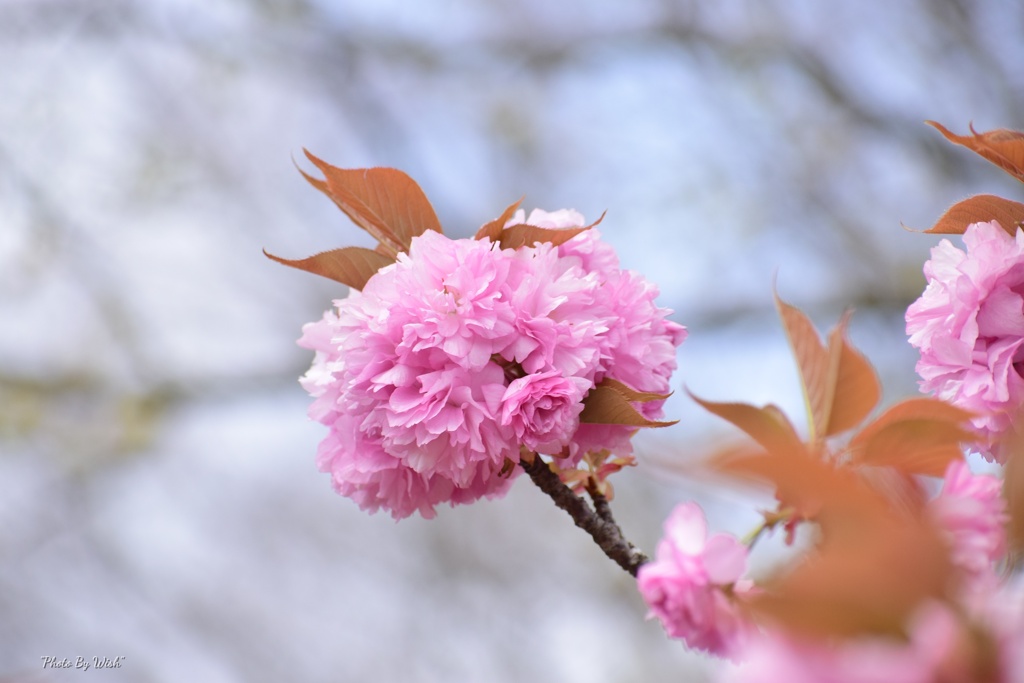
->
[695,297,975,636]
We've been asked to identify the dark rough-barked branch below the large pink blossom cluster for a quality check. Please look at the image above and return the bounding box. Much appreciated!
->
[519,456,647,577]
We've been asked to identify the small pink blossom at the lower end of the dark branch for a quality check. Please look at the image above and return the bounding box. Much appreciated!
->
[637,503,753,655]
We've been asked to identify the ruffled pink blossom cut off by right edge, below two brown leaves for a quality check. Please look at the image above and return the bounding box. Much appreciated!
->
[906,221,1024,462]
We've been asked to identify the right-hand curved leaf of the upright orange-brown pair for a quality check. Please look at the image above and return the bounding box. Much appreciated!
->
[821,317,882,436]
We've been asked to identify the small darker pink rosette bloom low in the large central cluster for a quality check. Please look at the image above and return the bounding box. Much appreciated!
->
[500,370,590,455]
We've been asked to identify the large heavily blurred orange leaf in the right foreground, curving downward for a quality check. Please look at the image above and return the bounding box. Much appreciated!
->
[719,432,952,637]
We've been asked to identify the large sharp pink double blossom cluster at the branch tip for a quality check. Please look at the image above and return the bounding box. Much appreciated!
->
[299,210,686,519]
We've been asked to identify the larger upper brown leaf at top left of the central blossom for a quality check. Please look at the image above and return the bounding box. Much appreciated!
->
[306,152,441,255]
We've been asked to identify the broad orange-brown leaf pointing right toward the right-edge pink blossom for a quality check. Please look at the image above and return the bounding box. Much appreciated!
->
[849,398,977,476]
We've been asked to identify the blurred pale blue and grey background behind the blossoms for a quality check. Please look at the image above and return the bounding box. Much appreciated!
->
[0,0,1024,683]
